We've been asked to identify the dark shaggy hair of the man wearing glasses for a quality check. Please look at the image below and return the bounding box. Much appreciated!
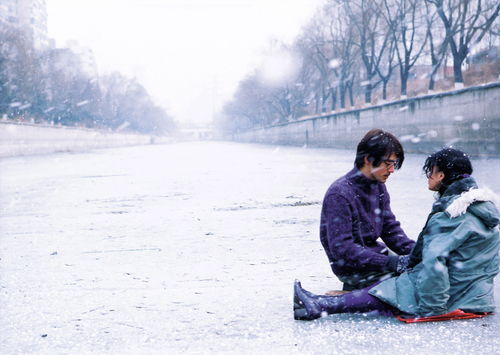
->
[354,128,405,169]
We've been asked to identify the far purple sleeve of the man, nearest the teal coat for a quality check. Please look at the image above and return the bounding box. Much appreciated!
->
[380,190,415,255]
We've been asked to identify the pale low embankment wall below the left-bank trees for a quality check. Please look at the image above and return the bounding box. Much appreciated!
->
[0,121,169,157]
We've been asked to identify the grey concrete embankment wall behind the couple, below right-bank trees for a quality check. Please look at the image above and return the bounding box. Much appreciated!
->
[232,82,500,157]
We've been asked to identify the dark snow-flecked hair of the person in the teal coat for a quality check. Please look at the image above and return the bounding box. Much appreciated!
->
[422,148,472,187]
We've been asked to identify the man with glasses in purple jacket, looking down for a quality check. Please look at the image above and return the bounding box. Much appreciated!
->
[320,129,415,291]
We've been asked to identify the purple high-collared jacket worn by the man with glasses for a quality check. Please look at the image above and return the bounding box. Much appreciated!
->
[320,167,415,276]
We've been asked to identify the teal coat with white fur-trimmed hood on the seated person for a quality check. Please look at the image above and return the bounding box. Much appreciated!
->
[369,177,500,316]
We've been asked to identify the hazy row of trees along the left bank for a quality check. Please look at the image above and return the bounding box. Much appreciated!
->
[0,24,174,134]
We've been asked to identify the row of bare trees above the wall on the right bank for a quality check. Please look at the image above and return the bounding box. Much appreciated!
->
[218,0,500,132]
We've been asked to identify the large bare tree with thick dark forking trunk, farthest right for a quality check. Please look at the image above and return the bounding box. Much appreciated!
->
[426,0,500,85]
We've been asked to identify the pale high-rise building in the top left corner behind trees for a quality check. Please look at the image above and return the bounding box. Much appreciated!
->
[0,0,49,49]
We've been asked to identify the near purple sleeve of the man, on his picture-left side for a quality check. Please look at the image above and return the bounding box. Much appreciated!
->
[323,194,389,271]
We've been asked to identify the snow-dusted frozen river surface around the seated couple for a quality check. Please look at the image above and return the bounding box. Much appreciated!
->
[0,142,500,354]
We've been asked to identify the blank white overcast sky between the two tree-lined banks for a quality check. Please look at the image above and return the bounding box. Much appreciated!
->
[47,0,323,123]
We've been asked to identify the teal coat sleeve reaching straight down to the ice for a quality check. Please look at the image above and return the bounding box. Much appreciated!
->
[416,212,471,316]
